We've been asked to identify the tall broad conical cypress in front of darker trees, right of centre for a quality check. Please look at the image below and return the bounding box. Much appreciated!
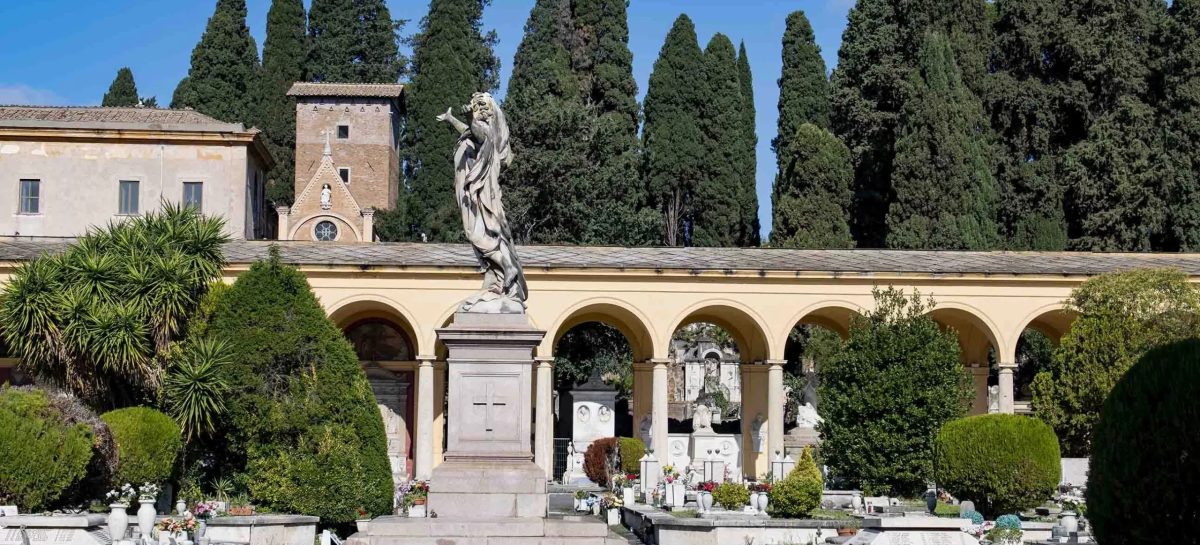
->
[887,32,998,250]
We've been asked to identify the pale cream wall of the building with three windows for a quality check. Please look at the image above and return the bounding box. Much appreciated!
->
[0,140,263,238]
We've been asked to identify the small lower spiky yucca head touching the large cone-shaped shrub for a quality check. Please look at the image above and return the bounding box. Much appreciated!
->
[163,339,233,443]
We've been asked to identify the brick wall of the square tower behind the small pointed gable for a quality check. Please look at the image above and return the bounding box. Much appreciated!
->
[295,97,398,210]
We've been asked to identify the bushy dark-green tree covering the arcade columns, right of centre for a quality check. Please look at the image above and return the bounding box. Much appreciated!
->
[817,288,972,496]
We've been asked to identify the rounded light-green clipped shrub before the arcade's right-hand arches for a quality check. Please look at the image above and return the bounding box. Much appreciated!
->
[935,414,1062,516]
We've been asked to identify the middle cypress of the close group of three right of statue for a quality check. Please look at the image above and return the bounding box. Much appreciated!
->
[691,32,745,246]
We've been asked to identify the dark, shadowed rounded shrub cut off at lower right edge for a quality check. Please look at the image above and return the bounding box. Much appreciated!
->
[1086,340,1200,537]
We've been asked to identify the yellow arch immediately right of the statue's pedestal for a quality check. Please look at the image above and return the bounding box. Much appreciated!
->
[538,298,659,361]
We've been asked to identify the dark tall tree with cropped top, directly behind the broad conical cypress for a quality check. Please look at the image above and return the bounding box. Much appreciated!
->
[830,0,991,247]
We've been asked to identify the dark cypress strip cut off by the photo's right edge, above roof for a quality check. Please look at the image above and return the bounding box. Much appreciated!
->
[1159,0,1200,252]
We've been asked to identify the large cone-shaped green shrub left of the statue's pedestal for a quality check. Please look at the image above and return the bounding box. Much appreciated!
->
[205,247,394,525]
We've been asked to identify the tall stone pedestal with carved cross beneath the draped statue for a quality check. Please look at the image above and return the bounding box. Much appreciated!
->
[428,312,546,520]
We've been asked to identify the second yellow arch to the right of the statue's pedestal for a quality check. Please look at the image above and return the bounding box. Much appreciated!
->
[655,299,768,363]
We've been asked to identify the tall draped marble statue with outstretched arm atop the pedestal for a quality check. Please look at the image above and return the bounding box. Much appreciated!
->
[437,92,528,315]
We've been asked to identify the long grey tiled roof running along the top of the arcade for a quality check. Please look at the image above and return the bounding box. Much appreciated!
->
[0,238,1200,276]
